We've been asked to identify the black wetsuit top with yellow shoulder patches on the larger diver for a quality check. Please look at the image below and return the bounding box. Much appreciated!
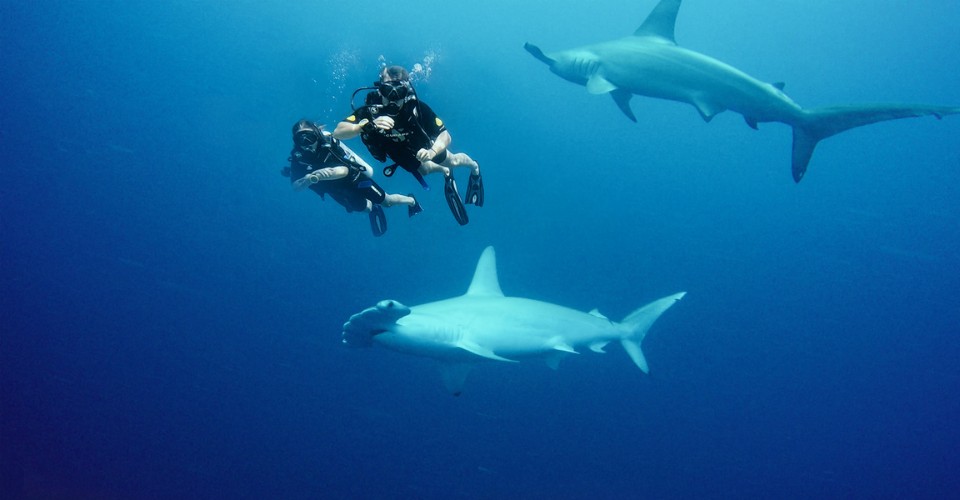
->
[344,92,447,172]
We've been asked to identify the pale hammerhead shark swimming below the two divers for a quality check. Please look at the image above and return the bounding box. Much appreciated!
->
[343,247,686,396]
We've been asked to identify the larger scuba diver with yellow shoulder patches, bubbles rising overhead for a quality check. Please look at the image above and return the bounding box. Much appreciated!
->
[333,66,483,226]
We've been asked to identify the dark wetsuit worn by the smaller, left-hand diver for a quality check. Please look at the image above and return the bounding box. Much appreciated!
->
[290,134,386,212]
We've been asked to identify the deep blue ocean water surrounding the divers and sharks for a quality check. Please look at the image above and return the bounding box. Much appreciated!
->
[0,0,960,498]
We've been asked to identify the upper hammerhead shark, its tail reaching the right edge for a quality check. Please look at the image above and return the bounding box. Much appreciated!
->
[524,0,960,182]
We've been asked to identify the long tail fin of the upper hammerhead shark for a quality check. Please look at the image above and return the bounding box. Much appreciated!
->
[791,104,960,182]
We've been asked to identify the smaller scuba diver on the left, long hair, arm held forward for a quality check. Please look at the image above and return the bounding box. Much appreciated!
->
[281,120,423,236]
